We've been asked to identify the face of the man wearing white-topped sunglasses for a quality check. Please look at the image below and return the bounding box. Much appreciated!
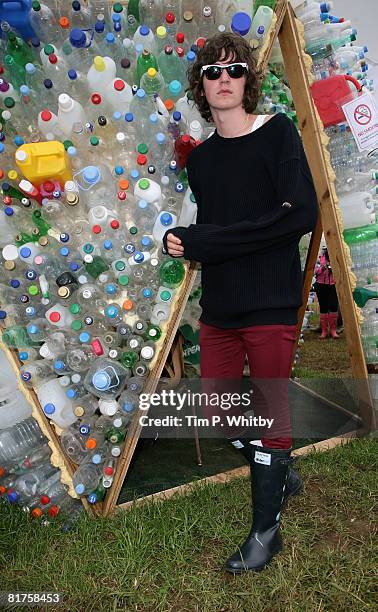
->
[202,52,246,110]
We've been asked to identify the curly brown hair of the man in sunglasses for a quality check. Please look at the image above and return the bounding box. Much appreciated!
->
[188,32,262,123]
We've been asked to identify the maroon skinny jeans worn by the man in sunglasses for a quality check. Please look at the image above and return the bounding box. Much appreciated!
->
[200,322,296,449]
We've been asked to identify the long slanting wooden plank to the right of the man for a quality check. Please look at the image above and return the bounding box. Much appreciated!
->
[279,6,374,433]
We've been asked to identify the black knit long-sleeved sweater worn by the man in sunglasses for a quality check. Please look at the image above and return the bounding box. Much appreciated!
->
[163,113,318,328]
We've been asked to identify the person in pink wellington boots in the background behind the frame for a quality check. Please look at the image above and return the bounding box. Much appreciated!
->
[315,247,339,340]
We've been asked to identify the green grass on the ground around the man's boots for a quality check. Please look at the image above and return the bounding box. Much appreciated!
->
[0,440,377,612]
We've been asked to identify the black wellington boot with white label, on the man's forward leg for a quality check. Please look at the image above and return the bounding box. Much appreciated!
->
[226,445,291,574]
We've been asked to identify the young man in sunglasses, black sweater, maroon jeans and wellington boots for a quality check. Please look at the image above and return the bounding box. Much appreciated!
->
[163,33,318,573]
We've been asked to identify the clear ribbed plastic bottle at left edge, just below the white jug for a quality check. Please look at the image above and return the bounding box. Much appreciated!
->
[0,417,45,464]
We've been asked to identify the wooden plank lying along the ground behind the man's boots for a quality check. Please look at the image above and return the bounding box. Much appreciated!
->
[117,431,357,510]
